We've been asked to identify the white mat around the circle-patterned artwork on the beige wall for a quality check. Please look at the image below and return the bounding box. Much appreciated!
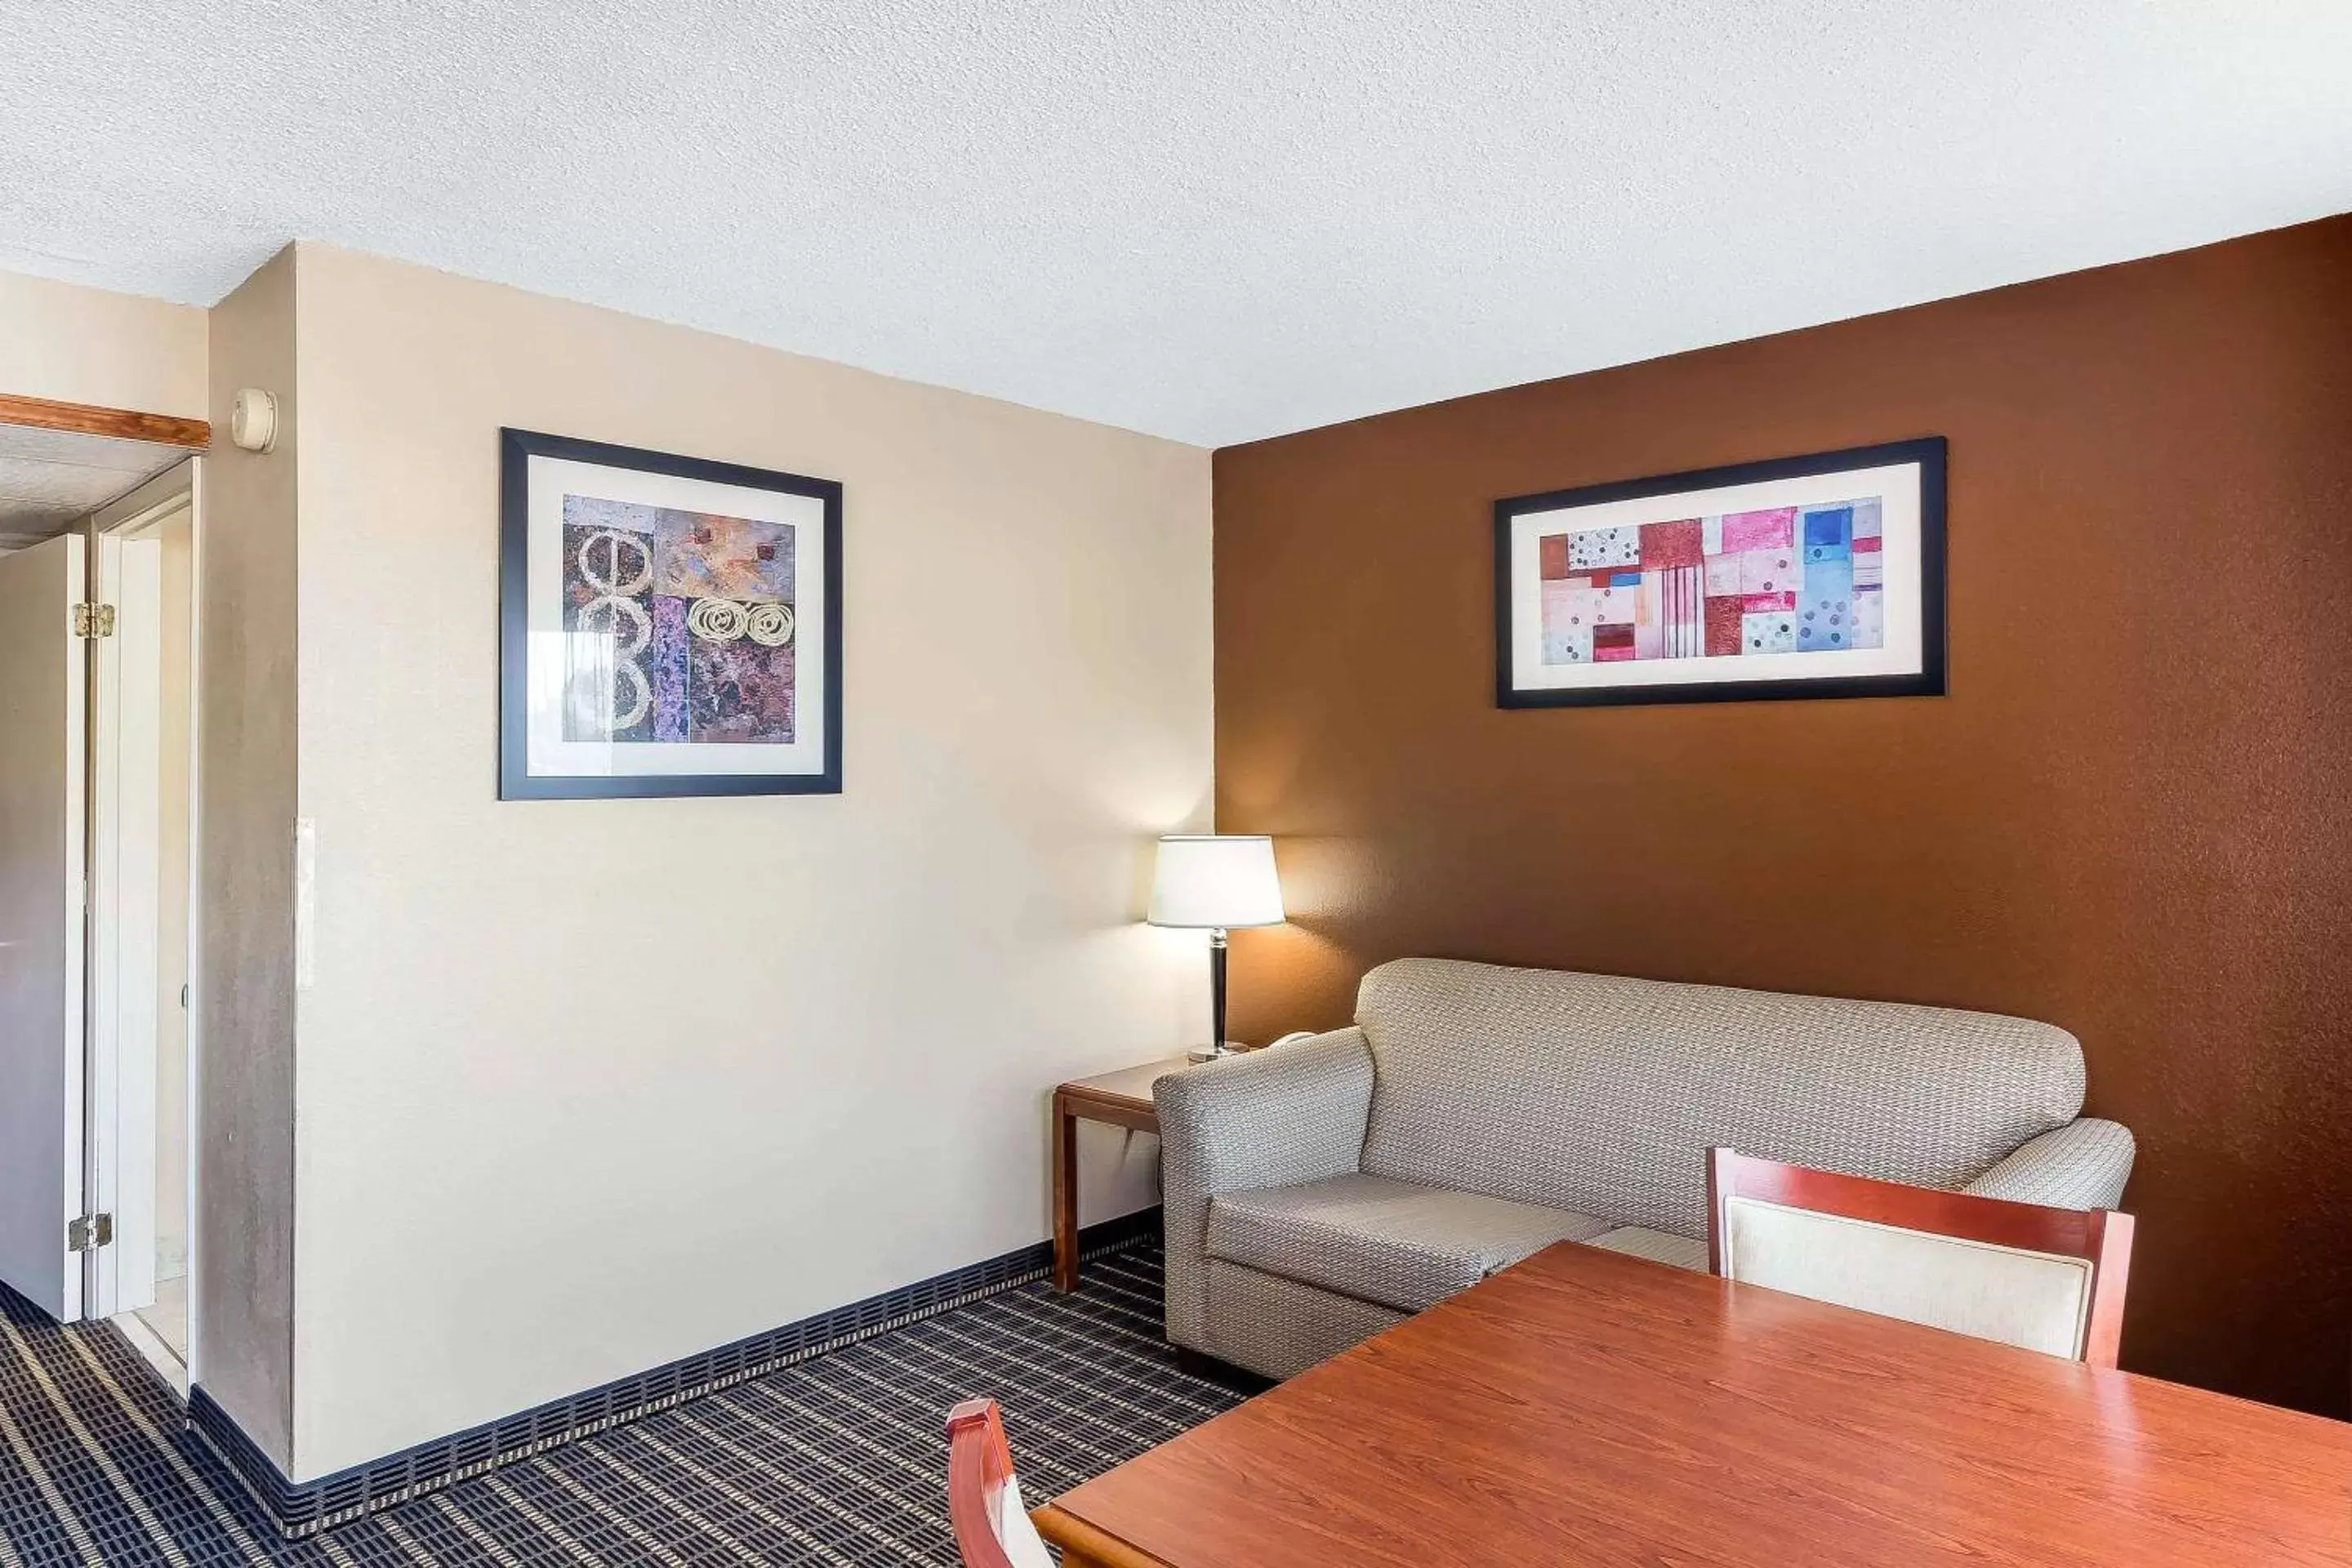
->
[522,454,833,778]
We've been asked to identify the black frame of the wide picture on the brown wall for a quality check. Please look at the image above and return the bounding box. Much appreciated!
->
[1494,435,1948,707]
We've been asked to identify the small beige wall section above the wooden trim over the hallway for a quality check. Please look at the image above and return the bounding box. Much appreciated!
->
[0,273,207,418]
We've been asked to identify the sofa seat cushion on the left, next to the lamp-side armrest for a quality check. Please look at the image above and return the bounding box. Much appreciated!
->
[1206,1173,1609,1312]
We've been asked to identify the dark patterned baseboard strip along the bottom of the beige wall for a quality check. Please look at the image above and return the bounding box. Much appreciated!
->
[188,1209,1160,1538]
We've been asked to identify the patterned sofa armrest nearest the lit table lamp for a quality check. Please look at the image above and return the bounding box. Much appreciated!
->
[1152,1027,1374,1349]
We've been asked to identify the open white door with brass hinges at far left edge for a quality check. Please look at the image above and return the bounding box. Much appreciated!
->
[0,536,87,1321]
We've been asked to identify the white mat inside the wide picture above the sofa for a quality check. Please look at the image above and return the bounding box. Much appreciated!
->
[1510,463,1927,691]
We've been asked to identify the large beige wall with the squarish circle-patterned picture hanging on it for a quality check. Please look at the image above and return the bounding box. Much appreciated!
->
[282,244,1211,1477]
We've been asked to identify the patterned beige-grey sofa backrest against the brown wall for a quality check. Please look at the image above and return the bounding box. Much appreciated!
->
[1355,959,2082,1236]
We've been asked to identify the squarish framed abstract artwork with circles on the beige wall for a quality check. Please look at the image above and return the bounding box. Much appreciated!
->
[499,430,842,800]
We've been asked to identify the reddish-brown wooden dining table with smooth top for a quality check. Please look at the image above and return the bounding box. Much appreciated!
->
[1032,1244,2352,1568]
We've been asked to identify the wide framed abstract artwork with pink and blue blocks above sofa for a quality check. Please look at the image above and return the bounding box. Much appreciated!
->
[1494,435,1943,707]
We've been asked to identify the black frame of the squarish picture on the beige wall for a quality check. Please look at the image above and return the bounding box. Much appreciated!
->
[499,428,844,800]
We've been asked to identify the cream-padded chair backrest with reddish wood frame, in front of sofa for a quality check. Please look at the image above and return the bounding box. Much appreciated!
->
[1708,1150,2131,1365]
